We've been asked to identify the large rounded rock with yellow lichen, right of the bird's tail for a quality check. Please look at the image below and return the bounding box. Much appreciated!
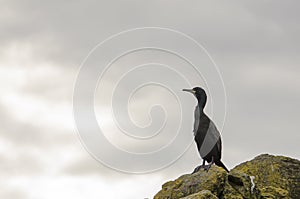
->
[230,154,300,198]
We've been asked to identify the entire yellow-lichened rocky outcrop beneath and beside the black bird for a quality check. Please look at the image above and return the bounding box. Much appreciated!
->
[154,154,300,199]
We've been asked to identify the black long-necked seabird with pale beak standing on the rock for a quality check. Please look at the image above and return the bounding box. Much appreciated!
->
[183,87,229,173]
